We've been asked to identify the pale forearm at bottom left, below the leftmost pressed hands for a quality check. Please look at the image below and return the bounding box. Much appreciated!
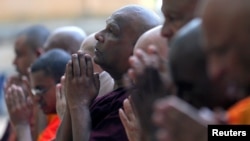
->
[15,124,32,141]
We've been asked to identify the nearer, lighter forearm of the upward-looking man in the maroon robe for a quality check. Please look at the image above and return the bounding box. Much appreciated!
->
[70,105,91,141]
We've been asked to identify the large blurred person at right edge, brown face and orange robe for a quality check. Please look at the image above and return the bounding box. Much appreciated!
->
[202,0,250,124]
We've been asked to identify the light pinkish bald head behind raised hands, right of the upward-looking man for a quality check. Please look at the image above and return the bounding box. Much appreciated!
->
[135,25,168,58]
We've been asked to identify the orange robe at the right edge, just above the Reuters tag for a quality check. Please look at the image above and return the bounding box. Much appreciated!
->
[227,97,250,124]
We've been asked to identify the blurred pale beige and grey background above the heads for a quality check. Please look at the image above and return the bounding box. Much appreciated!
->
[0,0,162,75]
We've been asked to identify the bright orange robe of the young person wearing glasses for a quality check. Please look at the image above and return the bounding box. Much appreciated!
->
[37,114,60,141]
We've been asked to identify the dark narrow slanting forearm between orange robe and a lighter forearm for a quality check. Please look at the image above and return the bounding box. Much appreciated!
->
[56,109,73,141]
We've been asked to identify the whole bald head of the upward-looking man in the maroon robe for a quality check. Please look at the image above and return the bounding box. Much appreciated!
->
[94,5,161,79]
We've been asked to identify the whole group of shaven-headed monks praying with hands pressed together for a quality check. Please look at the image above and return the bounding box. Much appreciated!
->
[0,0,250,141]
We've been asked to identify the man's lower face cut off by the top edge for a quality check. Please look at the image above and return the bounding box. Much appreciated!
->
[161,0,196,40]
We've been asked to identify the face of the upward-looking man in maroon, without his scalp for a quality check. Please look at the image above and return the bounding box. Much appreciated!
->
[94,10,136,78]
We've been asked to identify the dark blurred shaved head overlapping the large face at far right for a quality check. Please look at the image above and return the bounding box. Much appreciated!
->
[169,19,205,82]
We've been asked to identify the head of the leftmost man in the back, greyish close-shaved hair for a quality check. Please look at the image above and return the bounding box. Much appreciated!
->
[13,25,50,76]
